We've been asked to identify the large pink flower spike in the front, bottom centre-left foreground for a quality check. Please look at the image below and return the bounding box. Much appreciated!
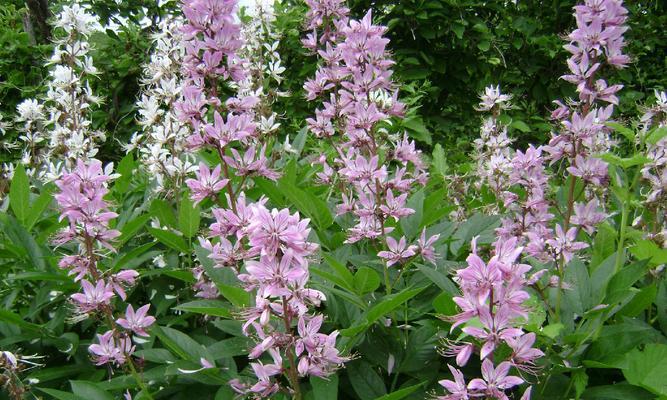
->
[201,193,347,397]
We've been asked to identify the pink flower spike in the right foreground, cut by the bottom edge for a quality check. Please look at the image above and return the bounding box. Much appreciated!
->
[438,238,544,400]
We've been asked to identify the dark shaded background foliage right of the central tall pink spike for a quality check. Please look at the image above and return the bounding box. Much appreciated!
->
[352,0,667,162]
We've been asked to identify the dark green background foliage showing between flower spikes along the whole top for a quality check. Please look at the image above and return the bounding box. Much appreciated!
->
[0,0,667,163]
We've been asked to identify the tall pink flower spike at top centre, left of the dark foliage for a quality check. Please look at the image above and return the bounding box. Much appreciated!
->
[304,7,436,258]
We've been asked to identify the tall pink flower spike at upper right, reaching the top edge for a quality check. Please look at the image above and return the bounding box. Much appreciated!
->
[544,0,629,197]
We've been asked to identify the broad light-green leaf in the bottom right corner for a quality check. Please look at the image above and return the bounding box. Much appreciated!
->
[623,343,667,396]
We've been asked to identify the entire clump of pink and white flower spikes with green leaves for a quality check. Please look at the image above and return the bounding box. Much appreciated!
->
[0,0,667,400]
